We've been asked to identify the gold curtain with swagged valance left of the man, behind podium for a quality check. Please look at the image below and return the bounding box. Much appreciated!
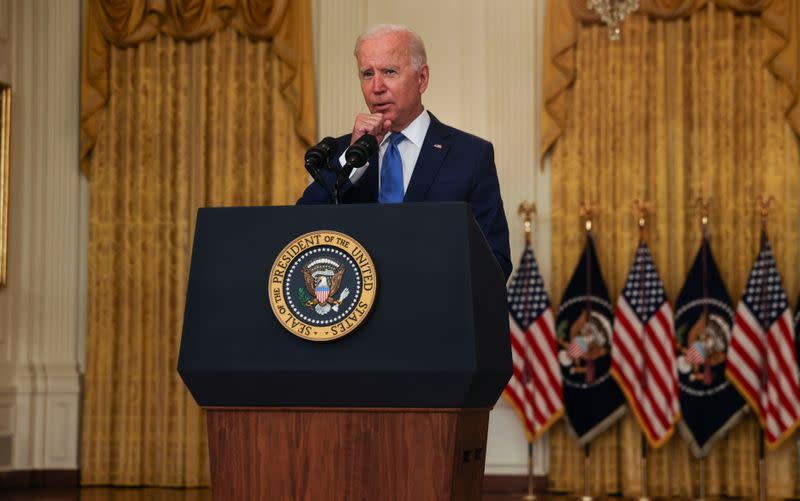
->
[81,0,315,486]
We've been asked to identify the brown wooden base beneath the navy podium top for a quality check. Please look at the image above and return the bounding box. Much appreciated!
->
[207,407,489,501]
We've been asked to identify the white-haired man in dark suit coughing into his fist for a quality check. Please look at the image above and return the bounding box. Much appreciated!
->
[298,25,511,278]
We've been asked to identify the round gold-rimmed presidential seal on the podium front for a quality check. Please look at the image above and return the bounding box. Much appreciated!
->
[269,230,377,341]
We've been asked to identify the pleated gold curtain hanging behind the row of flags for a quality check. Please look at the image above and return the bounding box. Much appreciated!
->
[542,0,800,498]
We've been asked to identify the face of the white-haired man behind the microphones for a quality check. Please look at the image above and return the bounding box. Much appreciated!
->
[357,33,428,132]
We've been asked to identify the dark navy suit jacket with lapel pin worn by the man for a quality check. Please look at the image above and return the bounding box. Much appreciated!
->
[297,114,511,279]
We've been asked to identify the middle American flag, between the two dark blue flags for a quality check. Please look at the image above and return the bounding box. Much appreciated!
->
[611,241,680,447]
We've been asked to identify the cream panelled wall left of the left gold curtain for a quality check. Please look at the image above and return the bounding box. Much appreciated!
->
[0,0,86,471]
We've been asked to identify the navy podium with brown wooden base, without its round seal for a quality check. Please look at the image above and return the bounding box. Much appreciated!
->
[178,202,511,501]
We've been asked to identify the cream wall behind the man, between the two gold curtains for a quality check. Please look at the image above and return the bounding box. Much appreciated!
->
[313,0,550,474]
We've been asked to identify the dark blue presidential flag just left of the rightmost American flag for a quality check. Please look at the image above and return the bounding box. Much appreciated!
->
[675,237,747,458]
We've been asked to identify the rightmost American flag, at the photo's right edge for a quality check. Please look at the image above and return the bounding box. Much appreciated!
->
[725,233,800,448]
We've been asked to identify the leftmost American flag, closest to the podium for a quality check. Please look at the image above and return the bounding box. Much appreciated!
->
[504,245,564,442]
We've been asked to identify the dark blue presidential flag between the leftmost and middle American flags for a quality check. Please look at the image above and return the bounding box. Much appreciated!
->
[556,232,625,446]
